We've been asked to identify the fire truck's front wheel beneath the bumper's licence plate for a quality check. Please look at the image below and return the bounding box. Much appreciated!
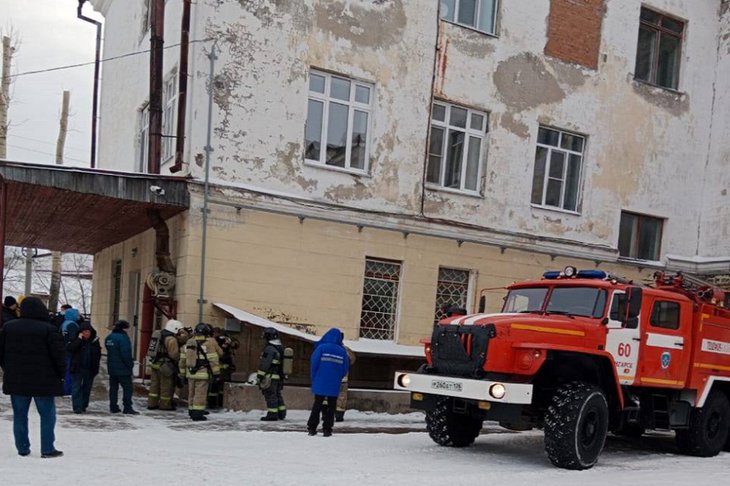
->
[426,398,482,447]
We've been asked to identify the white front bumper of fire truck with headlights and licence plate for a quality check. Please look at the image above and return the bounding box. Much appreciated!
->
[393,371,532,405]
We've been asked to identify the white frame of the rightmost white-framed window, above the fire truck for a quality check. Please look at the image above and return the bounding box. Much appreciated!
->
[530,125,588,215]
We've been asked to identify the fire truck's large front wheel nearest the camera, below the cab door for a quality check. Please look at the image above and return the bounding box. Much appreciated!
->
[545,382,608,469]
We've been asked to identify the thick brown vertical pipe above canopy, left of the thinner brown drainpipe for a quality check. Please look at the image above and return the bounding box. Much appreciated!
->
[147,0,165,174]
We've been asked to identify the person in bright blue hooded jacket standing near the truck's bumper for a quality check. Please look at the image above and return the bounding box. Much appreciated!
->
[307,327,350,437]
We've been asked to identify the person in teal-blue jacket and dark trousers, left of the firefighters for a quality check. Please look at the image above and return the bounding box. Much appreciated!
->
[104,321,139,415]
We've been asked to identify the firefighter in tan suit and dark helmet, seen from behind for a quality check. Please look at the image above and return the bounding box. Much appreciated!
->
[180,322,223,422]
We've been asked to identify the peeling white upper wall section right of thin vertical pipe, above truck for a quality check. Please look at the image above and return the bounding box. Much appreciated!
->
[427,0,730,262]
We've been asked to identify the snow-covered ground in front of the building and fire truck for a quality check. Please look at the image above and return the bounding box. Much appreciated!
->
[0,395,730,486]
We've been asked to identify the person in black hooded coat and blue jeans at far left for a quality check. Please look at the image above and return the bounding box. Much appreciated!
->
[0,297,66,458]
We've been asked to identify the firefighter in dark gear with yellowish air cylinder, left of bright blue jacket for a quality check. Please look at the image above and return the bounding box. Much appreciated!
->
[256,327,286,421]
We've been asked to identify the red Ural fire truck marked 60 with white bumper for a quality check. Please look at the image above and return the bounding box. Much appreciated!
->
[394,267,730,469]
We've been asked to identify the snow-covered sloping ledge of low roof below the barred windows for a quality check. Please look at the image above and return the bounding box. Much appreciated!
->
[213,303,425,358]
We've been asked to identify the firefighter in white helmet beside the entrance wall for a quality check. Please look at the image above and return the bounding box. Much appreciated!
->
[147,319,183,410]
